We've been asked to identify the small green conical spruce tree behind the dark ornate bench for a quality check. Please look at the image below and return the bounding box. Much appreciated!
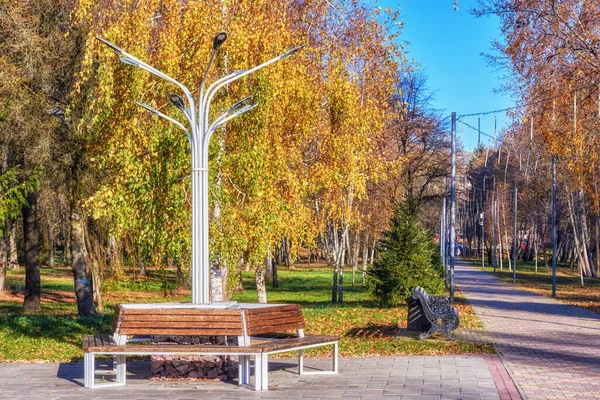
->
[367,203,444,307]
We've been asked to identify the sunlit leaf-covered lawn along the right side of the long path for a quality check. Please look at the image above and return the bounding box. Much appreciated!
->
[479,261,600,314]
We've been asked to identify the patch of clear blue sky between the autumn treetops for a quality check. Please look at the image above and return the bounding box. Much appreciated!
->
[378,0,514,150]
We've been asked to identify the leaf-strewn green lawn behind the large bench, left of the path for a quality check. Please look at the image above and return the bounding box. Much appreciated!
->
[0,265,493,361]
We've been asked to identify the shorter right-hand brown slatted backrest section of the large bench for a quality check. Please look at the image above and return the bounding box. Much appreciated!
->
[244,304,304,336]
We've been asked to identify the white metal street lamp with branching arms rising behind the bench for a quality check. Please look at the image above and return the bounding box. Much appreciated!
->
[97,32,305,304]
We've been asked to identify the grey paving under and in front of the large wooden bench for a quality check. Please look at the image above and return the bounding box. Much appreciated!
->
[0,356,500,400]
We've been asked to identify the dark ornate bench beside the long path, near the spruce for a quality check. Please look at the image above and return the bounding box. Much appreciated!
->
[411,286,460,339]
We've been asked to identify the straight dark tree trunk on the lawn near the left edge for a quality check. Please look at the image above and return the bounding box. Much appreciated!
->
[22,193,41,313]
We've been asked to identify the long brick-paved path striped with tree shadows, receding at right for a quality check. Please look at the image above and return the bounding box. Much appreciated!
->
[455,261,600,399]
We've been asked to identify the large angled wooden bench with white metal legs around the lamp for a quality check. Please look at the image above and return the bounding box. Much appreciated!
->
[83,304,339,390]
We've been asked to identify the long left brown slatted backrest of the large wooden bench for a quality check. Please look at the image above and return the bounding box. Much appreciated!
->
[113,306,244,336]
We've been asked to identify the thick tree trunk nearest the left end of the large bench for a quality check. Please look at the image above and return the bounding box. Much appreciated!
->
[71,208,96,317]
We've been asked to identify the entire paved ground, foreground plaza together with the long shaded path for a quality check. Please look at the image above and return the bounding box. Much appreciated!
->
[0,261,600,400]
